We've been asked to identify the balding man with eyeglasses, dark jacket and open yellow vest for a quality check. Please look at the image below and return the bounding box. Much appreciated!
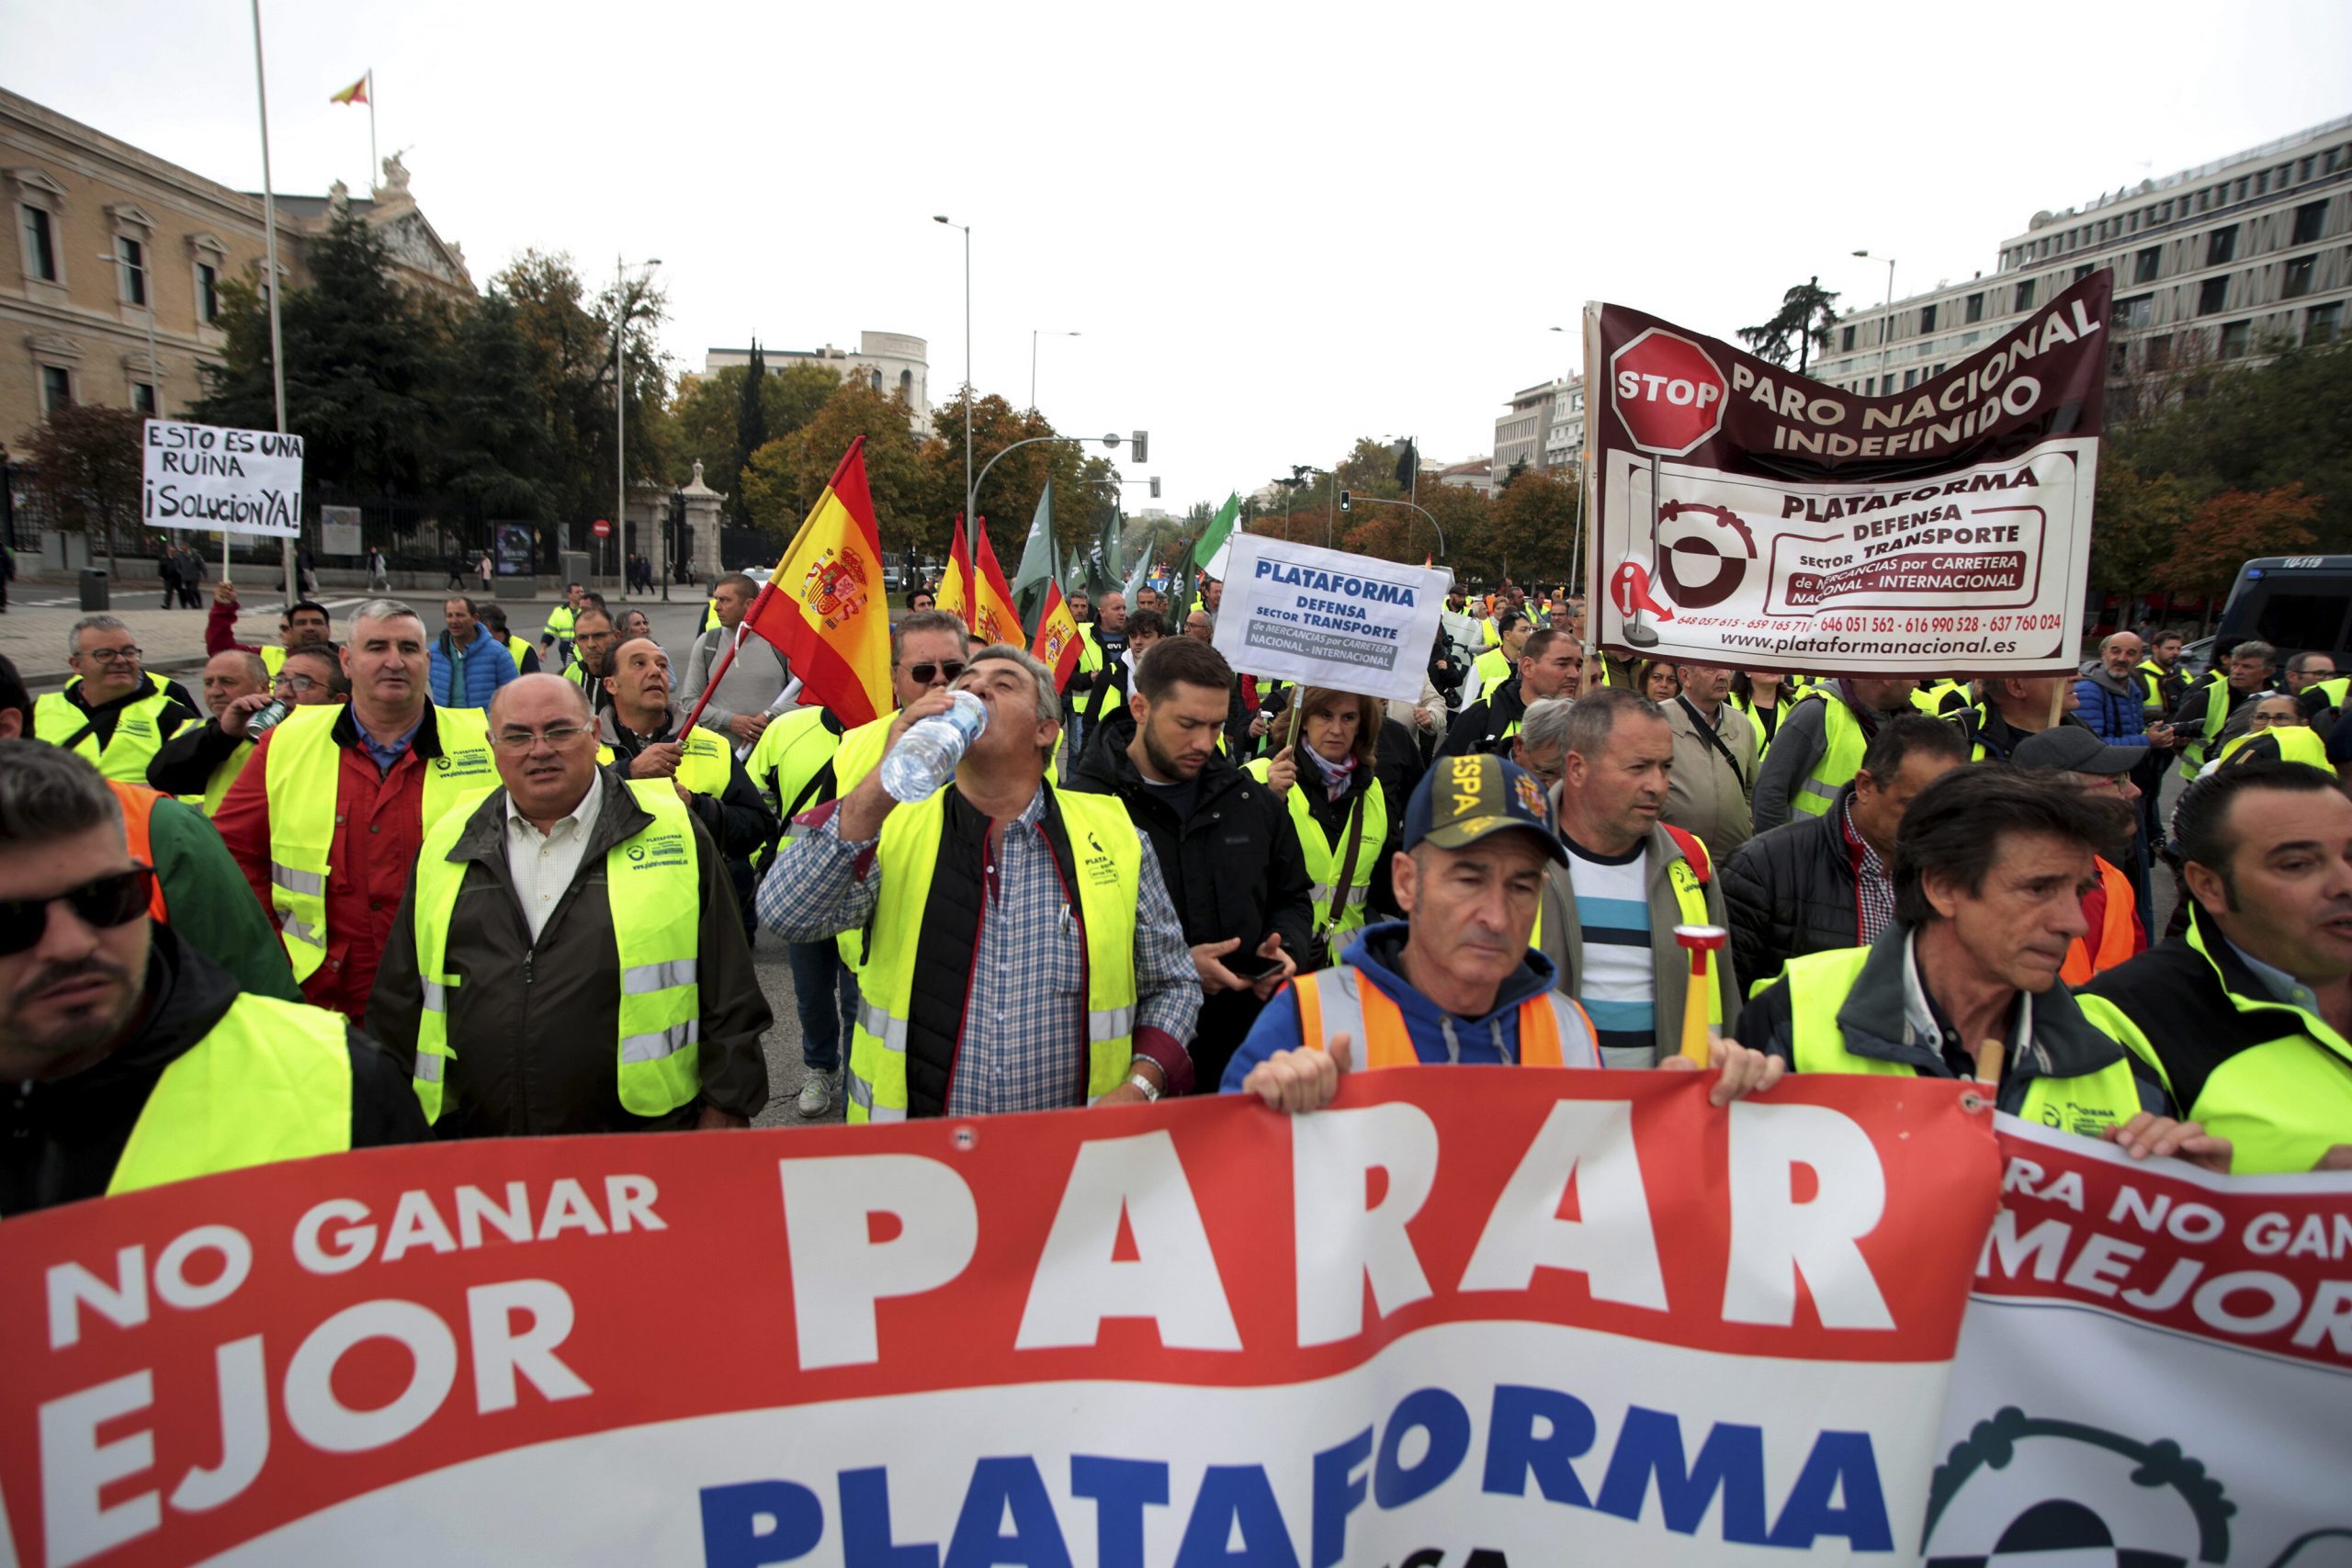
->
[367,677,772,1138]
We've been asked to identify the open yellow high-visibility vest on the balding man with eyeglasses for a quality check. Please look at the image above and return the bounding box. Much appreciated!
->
[414,778,700,1122]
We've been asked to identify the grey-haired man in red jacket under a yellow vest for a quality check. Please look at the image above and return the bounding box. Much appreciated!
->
[211,600,496,1018]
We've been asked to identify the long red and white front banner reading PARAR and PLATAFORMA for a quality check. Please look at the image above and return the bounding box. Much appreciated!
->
[0,1067,1995,1568]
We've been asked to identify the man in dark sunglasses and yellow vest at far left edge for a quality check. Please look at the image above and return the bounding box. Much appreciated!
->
[0,740,430,1218]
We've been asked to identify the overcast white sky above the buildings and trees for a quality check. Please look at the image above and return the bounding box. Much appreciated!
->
[0,0,2352,508]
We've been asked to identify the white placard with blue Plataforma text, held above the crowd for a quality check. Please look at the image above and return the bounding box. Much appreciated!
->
[1216,534,1446,703]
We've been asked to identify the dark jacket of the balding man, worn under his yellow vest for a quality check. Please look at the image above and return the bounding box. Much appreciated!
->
[367,771,774,1138]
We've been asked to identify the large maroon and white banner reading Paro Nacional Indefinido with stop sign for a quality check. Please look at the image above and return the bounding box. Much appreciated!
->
[1585,273,2108,674]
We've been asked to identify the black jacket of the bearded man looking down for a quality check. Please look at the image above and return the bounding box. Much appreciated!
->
[1070,728,1315,1086]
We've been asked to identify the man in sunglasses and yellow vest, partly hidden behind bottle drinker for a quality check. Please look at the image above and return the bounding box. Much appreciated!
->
[743,609,971,1119]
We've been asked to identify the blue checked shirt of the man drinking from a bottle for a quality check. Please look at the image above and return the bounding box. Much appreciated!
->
[760,785,1200,1117]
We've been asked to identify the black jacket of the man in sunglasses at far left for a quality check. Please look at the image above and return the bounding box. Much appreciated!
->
[0,926,433,1218]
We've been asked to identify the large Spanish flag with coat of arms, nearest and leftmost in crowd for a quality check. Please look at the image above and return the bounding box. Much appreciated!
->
[733,434,891,727]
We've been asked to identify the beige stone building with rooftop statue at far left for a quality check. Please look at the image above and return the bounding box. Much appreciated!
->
[0,89,473,456]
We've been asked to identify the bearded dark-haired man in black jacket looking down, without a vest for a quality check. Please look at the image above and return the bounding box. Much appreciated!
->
[1070,637,1315,1093]
